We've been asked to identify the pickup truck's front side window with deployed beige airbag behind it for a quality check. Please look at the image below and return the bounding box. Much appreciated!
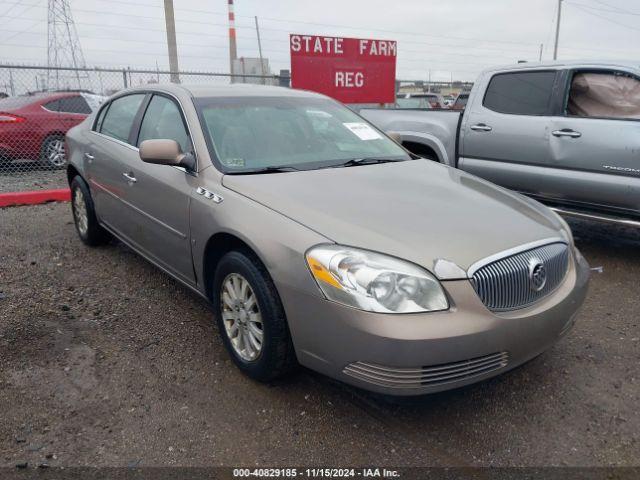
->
[566,72,640,119]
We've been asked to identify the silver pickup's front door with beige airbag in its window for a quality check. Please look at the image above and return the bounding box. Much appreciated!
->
[547,70,640,214]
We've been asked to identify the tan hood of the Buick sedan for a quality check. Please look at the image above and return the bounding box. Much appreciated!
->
[223,160,563,271]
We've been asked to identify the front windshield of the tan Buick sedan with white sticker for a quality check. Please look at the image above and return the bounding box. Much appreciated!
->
[195,96,411,173]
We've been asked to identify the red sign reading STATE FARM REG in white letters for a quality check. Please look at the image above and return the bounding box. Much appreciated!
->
[289,34,397,103]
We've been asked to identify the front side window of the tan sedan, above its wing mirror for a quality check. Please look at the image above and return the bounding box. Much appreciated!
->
[138,95,192,152]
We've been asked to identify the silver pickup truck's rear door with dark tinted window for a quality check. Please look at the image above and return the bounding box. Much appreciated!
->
[458,70,557,194]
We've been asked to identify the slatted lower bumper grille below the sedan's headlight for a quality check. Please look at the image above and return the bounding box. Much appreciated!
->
[343,352,509,388]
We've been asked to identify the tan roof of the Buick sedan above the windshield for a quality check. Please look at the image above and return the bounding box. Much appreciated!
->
[120,83,323,98]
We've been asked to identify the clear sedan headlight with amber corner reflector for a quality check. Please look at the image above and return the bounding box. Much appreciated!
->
[306,245,449,313]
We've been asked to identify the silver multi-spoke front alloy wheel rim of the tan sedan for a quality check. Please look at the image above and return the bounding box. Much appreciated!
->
[220,273,264,362]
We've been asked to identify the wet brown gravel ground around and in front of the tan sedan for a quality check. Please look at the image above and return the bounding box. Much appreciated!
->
[0,204,640,466]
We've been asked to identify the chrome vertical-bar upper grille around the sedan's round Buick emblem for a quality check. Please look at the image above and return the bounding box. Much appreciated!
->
[471,243,569,311]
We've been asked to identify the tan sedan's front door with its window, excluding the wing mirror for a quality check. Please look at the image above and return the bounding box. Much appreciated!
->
[121,93,197,283]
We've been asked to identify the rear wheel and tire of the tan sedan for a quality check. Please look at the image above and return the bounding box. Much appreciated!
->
[71,175,111,247]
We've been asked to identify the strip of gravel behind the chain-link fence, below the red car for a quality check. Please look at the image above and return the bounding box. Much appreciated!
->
[0,167,69,193]
